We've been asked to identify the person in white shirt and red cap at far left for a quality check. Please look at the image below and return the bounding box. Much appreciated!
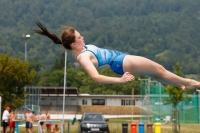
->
[2,106,10,133]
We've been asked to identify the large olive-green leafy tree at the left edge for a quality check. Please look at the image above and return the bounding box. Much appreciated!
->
[0,54,36,109]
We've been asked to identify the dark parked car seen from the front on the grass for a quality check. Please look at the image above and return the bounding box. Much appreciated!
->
[78,112,110,133]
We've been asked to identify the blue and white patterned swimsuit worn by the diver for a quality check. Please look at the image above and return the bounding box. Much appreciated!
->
[76,44,127,75]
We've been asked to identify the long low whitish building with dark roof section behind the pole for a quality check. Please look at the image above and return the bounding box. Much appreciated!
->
[38,87,141,106]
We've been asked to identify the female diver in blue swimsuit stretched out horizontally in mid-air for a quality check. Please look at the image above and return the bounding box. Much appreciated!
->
[33,21,200,90]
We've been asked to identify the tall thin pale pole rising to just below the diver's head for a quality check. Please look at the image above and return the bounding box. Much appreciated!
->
[62,50,67,133]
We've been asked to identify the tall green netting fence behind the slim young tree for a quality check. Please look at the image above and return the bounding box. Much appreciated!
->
[141,80,200,123]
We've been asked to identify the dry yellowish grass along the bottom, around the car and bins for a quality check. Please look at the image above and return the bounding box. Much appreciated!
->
[3,118,200,133]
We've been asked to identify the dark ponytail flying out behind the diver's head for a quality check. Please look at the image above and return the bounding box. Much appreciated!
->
[33,21,62,44]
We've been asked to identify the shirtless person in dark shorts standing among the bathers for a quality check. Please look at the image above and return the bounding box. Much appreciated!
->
[25,109,34,133]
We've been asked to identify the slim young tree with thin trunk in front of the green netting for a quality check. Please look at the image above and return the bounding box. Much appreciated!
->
[164,62,191,133]
